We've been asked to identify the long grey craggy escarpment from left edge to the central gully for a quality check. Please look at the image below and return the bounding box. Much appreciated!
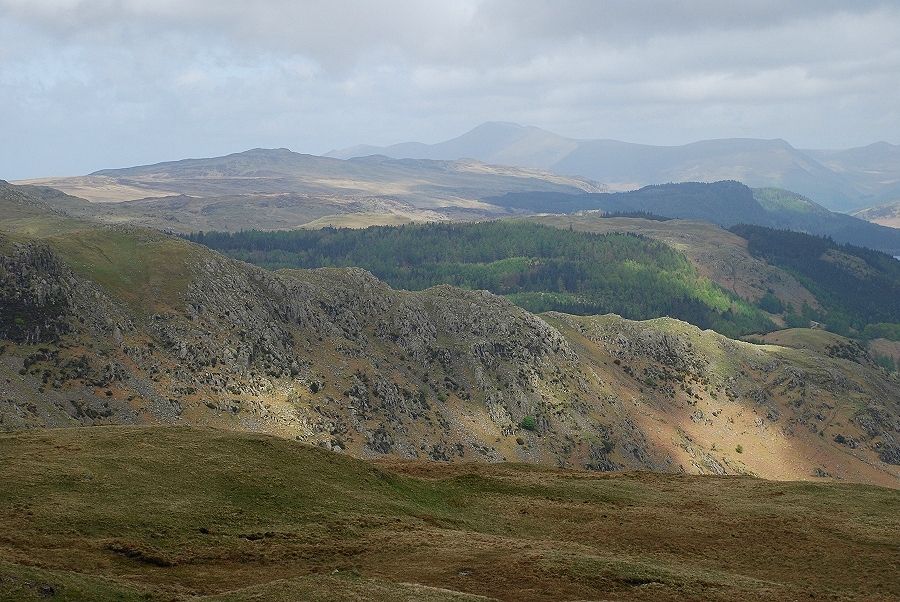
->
[0,231,664,468]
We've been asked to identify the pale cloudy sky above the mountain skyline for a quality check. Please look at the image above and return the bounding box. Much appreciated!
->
[0,0,900,180]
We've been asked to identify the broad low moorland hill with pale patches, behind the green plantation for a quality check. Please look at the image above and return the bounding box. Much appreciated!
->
[17,148,604,232]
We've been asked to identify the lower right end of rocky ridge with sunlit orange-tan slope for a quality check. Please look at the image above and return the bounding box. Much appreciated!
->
[548,314,900,482]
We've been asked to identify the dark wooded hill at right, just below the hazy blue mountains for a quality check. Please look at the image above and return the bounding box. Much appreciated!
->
[487,181,900,255]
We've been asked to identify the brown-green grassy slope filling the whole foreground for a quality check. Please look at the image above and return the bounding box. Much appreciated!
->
[0,427,900,600]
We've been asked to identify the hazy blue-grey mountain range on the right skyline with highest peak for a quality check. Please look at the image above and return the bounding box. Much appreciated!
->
[327,122,900,211]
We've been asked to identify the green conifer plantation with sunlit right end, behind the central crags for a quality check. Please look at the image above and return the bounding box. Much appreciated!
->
[189,221,774,336]
